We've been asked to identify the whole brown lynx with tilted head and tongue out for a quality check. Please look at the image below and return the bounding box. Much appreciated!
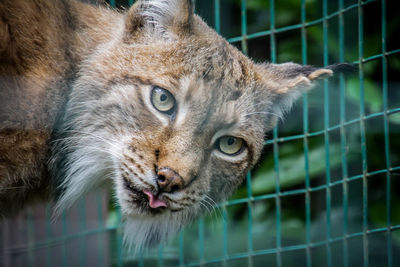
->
[0,0,332,247]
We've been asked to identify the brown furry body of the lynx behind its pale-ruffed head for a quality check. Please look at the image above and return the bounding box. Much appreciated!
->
[0,0,121,214]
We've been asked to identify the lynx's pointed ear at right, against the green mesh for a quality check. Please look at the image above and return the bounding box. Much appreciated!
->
[258,63,333,116]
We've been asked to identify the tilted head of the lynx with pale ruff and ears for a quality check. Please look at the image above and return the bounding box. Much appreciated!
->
[53,0,332,249]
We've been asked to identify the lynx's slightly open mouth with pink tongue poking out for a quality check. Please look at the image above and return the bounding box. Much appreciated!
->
[124,178,167,213]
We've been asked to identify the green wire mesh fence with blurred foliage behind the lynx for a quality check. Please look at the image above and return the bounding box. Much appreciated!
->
[0,0,400,267]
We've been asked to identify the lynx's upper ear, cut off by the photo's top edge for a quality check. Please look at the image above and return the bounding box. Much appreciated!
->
[125,0,194,39]
